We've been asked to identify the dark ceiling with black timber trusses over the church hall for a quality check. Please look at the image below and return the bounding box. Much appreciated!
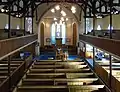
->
[0,0,120,18]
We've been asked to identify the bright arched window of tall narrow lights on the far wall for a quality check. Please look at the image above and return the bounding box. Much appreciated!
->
[51,23,66,44]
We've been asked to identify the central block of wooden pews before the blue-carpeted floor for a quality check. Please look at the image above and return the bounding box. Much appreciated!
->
[14,60,105,92]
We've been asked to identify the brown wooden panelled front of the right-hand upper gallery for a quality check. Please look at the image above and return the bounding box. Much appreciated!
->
[79,35,120,57]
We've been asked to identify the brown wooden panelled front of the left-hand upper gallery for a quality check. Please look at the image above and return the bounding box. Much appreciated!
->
[0,35,37,57]
